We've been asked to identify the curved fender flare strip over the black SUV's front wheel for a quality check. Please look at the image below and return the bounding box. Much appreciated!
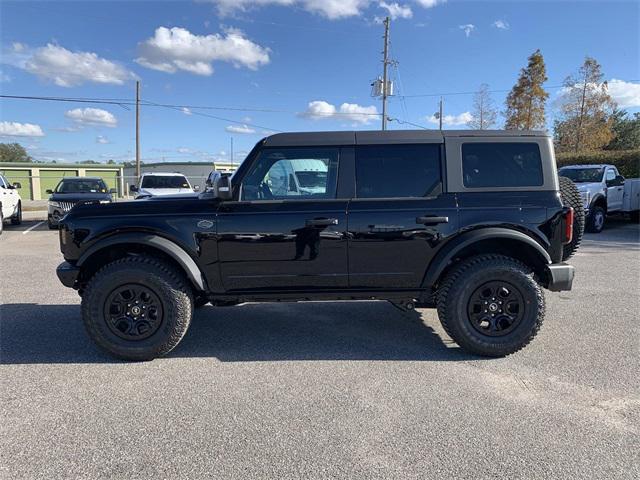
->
[76,233,206,291]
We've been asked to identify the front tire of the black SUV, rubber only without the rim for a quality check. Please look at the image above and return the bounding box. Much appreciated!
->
[82,256,193,361]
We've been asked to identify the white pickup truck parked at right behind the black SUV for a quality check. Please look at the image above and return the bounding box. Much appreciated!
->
[558,164,640,233]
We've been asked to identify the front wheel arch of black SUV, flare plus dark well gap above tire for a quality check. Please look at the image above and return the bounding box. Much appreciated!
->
[76,233,206,291]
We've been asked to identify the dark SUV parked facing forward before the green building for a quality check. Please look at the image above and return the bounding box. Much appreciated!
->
[47,177,116,229]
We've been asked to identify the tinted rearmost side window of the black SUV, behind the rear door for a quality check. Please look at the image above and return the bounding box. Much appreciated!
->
[462,143,544,188]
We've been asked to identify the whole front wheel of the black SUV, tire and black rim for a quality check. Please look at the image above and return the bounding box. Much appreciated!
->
[82,256,193,360]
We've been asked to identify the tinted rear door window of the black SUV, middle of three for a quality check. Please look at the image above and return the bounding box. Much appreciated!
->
[356,144,442,198]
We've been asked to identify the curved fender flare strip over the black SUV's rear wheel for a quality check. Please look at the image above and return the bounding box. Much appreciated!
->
[423,227,551,287]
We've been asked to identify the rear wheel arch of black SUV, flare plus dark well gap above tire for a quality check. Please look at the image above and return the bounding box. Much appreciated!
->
[423,227,552,288]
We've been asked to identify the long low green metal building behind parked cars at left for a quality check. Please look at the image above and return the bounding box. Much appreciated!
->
[0,162,125,200]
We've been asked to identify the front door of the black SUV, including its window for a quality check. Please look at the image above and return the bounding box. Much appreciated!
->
[217,147,348,292]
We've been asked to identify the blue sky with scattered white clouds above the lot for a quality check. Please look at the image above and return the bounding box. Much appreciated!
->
[0,0,640,162]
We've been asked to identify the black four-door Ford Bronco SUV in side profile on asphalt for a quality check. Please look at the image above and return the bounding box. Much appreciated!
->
[57,130,584,360]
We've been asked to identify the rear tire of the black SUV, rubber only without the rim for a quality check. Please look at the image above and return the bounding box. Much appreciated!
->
[436,254,545,357]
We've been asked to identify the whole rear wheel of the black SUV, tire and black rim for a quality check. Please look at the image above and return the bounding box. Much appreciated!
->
[436,255,545,357]
